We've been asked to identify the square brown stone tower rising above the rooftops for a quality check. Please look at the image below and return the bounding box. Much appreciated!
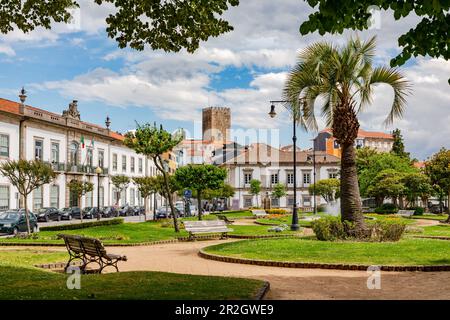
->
[202,107,231,142]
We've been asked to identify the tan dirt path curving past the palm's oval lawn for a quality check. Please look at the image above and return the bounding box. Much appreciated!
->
[103,240,450,299]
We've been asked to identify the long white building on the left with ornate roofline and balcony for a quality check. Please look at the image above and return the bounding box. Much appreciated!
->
[0,94,160,211]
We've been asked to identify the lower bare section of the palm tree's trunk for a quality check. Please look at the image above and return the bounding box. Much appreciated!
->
[341,144,364,229]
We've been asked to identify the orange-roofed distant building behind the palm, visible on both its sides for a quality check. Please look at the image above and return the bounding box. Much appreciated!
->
[314,128,394,158]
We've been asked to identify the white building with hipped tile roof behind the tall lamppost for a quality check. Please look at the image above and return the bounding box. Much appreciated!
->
[223,143,340,211]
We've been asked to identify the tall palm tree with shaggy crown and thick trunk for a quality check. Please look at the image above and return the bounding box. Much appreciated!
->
[283,37,410,228]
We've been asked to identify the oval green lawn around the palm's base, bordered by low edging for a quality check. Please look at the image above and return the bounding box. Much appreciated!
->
[206,238,450,265]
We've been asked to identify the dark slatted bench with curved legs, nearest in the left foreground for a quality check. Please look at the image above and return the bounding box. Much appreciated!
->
[58,234,127,273]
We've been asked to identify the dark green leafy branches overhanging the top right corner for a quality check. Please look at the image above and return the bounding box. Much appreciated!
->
[300,0,450,81]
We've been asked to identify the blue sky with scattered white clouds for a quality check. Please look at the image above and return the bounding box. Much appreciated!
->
[0,0,450,159]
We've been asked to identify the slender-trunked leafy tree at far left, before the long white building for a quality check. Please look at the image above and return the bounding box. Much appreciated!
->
[0,160,56,234]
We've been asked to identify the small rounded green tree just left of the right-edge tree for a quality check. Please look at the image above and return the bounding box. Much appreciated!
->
[402,172,434,208]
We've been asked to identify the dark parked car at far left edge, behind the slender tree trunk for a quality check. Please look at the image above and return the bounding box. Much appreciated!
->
[0,209,39,235]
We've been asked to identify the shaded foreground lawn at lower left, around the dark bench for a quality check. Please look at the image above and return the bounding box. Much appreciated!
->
[0,249,262,300]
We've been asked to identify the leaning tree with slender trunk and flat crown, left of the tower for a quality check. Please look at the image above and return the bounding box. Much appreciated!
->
[124,123,183,232]
